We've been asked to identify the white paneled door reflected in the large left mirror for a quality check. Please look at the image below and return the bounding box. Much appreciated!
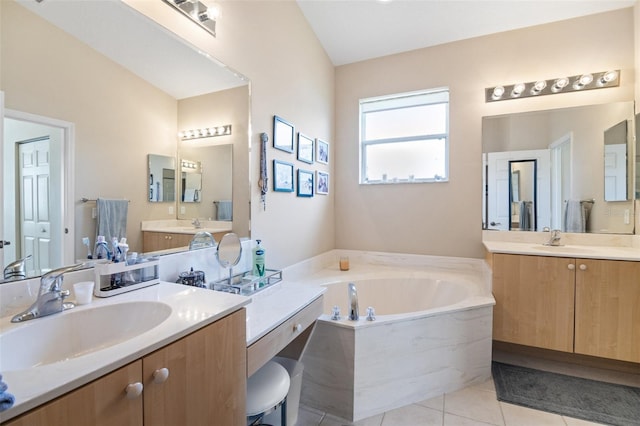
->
[18,138,54,272]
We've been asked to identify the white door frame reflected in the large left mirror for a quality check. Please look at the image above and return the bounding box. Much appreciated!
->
[0,108,75,266]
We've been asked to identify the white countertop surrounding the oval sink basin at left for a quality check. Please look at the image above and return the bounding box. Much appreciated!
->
[0,283,251,422]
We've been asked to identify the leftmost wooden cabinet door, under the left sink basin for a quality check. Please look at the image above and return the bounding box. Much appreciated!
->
[5,361,142,426]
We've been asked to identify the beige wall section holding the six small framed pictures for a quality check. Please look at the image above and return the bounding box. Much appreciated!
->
[126,0,338,268]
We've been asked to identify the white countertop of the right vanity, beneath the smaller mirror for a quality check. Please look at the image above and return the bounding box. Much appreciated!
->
[482,241,640,261]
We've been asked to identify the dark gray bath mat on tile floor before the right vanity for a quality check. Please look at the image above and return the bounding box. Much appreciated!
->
[491,362,640,426]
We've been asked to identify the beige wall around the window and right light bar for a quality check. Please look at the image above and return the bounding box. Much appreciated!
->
[334,9,635,257]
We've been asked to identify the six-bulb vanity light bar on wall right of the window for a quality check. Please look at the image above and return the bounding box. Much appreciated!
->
[484,70,620,102]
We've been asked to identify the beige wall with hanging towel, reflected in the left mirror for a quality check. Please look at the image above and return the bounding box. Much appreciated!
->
[0,1,177,253]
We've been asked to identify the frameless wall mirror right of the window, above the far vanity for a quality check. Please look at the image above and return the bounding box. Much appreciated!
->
[482,102,634,234]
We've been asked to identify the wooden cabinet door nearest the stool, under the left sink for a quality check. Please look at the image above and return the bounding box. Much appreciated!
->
[143,309,247,426]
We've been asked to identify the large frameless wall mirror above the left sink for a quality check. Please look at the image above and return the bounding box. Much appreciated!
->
[0,0,250,280]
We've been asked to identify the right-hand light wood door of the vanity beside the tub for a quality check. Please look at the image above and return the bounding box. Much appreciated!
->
[575,259,640,362]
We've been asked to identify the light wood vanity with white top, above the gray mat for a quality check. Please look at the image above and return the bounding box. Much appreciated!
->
[484,241,640,363]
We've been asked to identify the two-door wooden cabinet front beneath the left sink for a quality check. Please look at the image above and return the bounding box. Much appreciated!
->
[3,309,246,426]
